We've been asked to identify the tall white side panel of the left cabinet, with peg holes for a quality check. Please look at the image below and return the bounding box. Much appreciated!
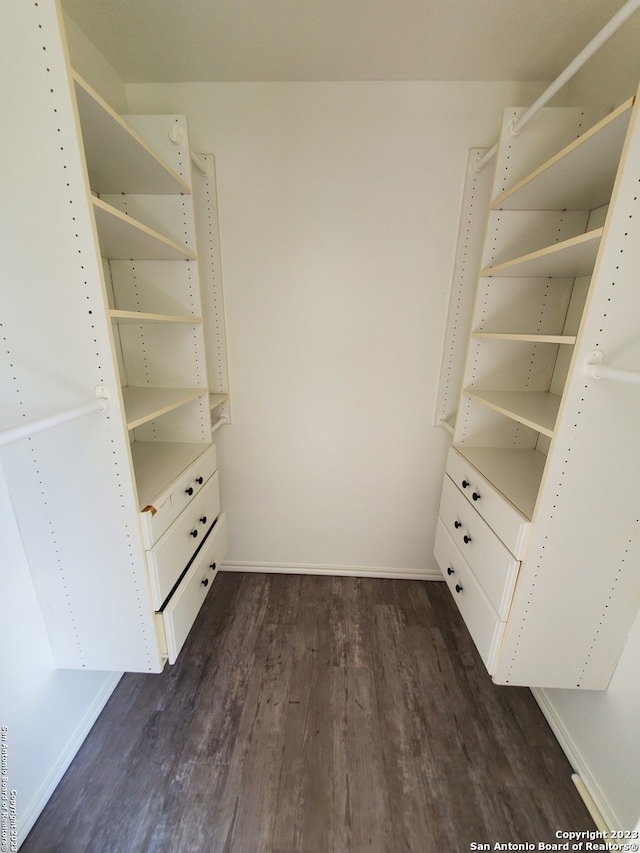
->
[0,2,161,671]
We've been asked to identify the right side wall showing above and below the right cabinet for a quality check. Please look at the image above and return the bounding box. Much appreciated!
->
[539,20,640,829]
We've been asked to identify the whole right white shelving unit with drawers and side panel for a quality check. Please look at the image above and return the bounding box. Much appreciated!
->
[436,91,640,689]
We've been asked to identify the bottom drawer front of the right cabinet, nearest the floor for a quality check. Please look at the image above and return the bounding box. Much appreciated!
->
[434,519,506,673]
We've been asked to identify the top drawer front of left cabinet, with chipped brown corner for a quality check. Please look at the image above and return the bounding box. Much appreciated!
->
[140,444,218,550]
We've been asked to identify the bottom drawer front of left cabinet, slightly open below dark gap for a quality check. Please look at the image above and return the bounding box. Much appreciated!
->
[162,513,227,663]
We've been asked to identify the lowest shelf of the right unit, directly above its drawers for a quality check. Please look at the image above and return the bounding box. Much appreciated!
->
[456,444,547,520]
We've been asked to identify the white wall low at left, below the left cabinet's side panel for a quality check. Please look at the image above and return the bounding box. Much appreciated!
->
[0,468,119,841]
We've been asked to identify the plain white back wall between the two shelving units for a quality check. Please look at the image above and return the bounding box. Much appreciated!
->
[127,82,541,576]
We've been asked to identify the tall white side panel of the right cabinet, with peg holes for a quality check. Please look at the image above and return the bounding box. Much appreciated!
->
[496,100,640,689]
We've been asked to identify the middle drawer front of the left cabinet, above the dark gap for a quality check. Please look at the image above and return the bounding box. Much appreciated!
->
[147,474,220,610]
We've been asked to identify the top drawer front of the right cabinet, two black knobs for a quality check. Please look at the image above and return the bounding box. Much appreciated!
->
[447,448,531,560]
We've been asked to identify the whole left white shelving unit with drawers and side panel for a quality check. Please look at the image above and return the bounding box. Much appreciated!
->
[0,2,229,672]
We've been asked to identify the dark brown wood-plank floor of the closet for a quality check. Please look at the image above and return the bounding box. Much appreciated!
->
[21,574,594,853]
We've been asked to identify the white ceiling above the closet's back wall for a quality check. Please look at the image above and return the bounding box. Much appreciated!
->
[62,0,624,82]
